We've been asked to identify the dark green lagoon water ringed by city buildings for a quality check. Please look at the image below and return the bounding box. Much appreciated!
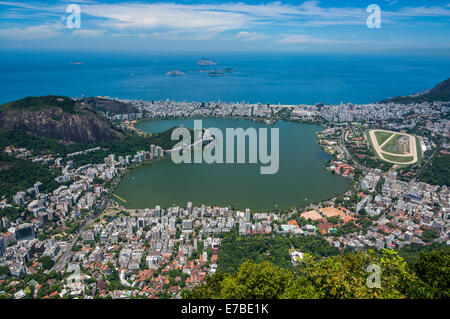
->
[115,119,350,210]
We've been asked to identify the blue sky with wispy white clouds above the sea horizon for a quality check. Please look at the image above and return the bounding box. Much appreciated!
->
[0,0,450,54]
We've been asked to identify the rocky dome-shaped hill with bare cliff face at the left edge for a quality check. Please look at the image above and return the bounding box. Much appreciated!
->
[0,95,123,143]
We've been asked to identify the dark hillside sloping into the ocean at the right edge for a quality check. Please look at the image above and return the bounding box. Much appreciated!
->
[381,78,450,104]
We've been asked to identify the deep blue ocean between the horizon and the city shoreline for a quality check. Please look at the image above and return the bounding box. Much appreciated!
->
[0,51,450,104]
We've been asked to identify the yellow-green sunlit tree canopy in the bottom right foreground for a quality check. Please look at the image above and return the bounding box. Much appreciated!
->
[183,249,450,299]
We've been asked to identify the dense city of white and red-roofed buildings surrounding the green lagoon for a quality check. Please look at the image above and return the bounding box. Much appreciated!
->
[0,97,450,298]
